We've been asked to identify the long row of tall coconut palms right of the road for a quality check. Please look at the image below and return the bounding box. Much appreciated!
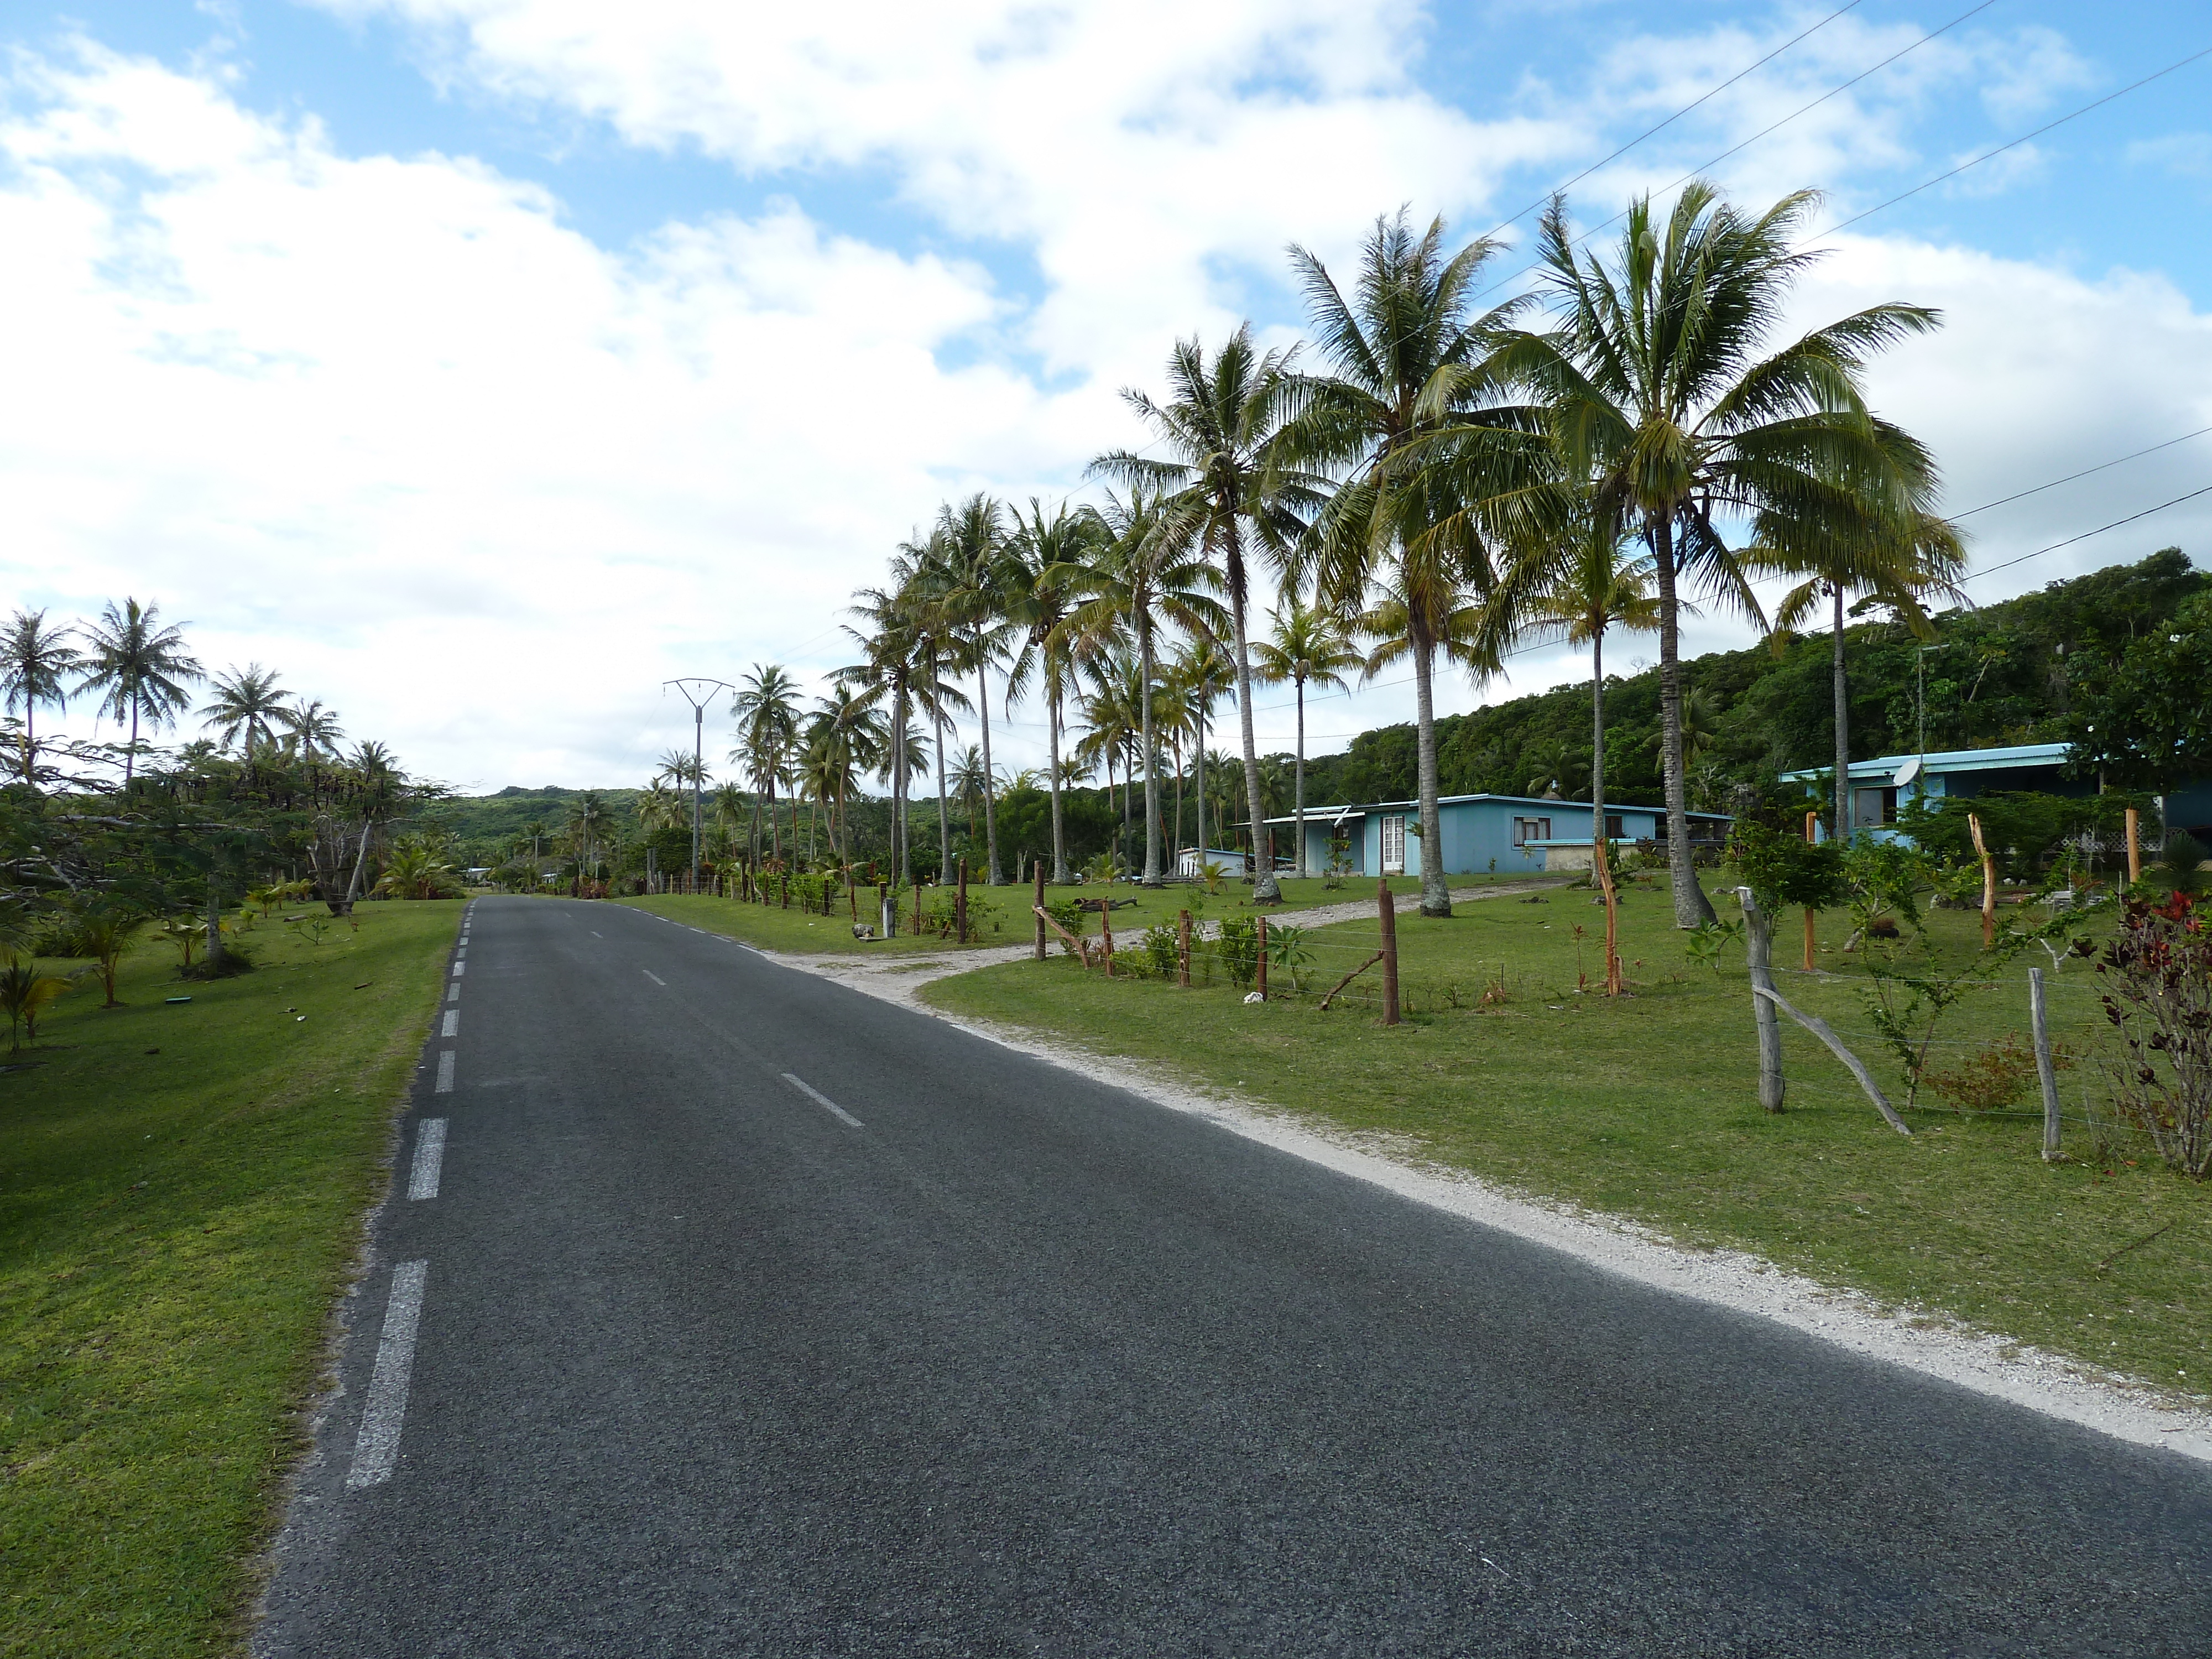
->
[832,181,1962,927]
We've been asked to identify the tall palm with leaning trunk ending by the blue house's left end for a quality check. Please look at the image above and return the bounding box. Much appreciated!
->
[1091,323,1325,902]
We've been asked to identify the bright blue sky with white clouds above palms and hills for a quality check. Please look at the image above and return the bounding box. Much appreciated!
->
[0,0,2212,787]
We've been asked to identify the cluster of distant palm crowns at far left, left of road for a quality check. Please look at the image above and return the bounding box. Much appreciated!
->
[0,599,363,787]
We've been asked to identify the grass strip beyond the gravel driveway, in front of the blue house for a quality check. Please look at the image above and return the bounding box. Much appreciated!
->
[613,876,1566,956]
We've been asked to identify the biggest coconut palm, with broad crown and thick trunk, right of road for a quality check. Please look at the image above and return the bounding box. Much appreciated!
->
[1511,191,1938,927]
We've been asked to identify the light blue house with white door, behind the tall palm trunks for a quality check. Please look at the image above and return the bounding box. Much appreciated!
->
[1267,794,1728,876]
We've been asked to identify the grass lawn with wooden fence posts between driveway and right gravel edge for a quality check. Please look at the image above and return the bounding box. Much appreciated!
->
[922,887,2212,1394]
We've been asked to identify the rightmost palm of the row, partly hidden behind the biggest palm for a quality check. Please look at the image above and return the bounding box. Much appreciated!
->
[1743,513,1966,841]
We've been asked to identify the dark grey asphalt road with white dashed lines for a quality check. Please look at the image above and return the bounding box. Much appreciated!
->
[257,900,2212,1659]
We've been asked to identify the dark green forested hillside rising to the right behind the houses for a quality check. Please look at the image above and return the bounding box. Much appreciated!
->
[434,549,2212,874]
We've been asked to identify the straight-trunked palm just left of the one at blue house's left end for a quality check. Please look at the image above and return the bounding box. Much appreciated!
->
[1068,487,1228,887]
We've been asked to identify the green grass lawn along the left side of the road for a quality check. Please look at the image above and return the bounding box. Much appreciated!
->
[0,902,460,1659]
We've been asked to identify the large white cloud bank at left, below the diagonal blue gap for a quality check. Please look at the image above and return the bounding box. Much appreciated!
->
[0,46,1071,781]
